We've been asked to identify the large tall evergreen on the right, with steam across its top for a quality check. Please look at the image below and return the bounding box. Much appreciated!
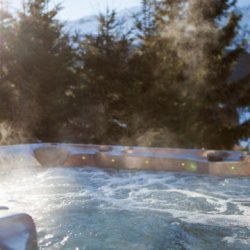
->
[155,0,249,148]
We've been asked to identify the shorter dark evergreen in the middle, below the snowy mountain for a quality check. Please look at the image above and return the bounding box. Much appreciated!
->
[74,11,132,144]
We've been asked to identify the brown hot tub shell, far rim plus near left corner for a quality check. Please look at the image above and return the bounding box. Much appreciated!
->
[0,143,250,250]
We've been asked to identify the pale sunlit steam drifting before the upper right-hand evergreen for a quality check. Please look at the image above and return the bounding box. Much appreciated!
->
[159,0,229,84]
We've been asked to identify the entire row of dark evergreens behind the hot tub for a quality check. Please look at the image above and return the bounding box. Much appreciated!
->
[0,0,250,149]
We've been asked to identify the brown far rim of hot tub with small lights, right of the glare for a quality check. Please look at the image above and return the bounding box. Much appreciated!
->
[34,144,250,176]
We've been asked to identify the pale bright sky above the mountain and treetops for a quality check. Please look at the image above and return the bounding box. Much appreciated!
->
[9,0,250,20]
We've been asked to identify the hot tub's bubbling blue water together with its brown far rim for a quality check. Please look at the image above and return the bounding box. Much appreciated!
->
[0,144,250,250]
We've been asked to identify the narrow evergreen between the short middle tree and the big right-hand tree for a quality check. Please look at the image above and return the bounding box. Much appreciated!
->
[126,0,185,146]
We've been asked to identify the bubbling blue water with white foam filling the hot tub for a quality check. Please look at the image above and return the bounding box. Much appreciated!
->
[0,167,250,250]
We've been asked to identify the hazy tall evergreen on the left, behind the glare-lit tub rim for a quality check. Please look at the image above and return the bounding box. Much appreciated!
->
[13,0,76,141]
